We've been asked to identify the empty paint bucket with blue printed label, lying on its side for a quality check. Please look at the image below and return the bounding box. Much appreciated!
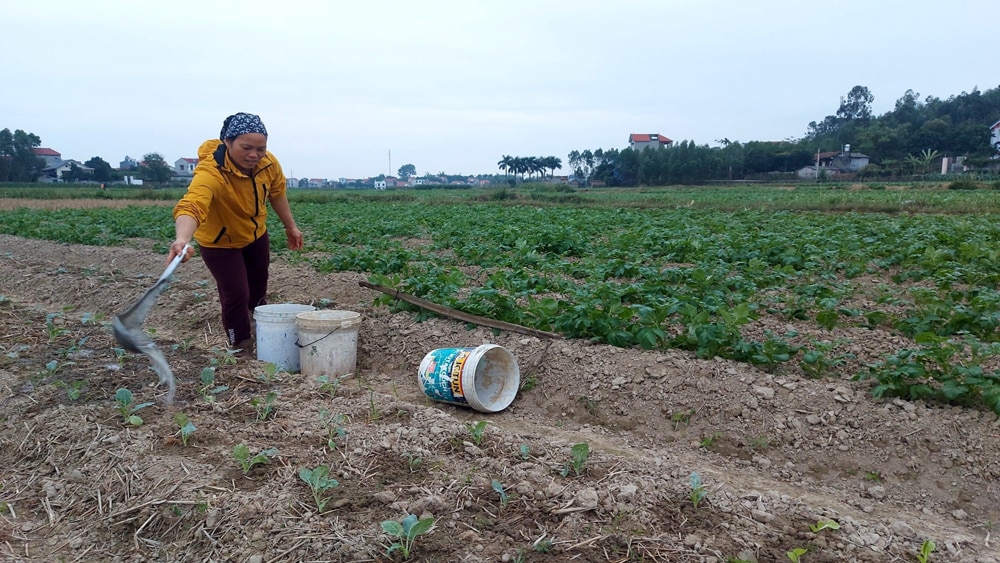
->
[417,344,521,412]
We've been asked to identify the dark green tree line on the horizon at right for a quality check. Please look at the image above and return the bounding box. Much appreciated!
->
[569,86,1000,186]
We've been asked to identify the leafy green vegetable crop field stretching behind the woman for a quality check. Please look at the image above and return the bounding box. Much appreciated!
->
[0,186,1000,414]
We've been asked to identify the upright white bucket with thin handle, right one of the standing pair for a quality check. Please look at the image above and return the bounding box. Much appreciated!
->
[295,309,361,376]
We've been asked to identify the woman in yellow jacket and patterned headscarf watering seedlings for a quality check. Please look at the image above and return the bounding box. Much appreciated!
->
[167,113,302,352]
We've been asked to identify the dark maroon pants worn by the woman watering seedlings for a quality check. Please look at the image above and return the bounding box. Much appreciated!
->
[201,233,271,345]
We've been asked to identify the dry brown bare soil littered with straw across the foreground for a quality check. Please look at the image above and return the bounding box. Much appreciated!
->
[0,219,1000,563]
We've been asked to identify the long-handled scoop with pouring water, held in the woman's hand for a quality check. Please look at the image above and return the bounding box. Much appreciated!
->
[111,245,190,405]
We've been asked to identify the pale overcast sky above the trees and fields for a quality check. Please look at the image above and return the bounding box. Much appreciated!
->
[0,0,1000,179]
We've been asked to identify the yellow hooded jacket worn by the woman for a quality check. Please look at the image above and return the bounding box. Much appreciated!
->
[174,139,285,248]
